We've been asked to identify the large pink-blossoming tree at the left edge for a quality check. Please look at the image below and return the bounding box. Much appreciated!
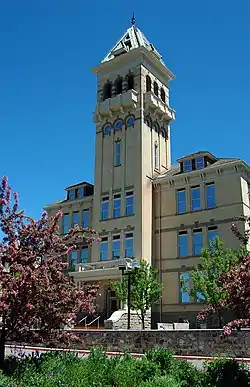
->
[0,177,98,367]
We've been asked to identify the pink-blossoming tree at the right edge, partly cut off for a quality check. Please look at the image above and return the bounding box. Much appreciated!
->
[199,216,250,335]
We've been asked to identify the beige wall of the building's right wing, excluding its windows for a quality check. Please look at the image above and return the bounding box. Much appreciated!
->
[152,163,250,319]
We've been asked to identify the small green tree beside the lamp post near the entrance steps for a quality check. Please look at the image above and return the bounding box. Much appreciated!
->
[112,260,163,329]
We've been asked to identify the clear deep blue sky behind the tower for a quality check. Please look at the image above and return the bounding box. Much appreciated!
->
[0,0,250,218]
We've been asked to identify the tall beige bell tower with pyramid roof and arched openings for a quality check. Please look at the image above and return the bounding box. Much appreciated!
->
[92,18,174,262]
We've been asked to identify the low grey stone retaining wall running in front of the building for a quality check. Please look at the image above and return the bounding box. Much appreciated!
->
[64,329,250,357]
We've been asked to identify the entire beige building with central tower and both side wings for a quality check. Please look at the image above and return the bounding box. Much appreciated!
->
[46,24,250,323]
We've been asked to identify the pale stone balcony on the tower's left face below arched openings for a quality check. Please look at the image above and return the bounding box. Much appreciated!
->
[95,89,138,121]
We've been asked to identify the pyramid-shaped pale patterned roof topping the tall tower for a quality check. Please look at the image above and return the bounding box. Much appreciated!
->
[102,25,164,65]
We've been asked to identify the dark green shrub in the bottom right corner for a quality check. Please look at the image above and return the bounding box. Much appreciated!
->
[206,359,250,387]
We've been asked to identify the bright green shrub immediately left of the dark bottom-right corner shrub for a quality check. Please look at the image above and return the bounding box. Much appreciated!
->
[171,360,206,387]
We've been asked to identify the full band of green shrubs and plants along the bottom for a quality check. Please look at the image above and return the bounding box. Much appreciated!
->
[0,349,250,387]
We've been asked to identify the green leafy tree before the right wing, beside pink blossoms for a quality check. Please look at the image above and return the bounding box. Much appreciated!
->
[182,237,237,328]
